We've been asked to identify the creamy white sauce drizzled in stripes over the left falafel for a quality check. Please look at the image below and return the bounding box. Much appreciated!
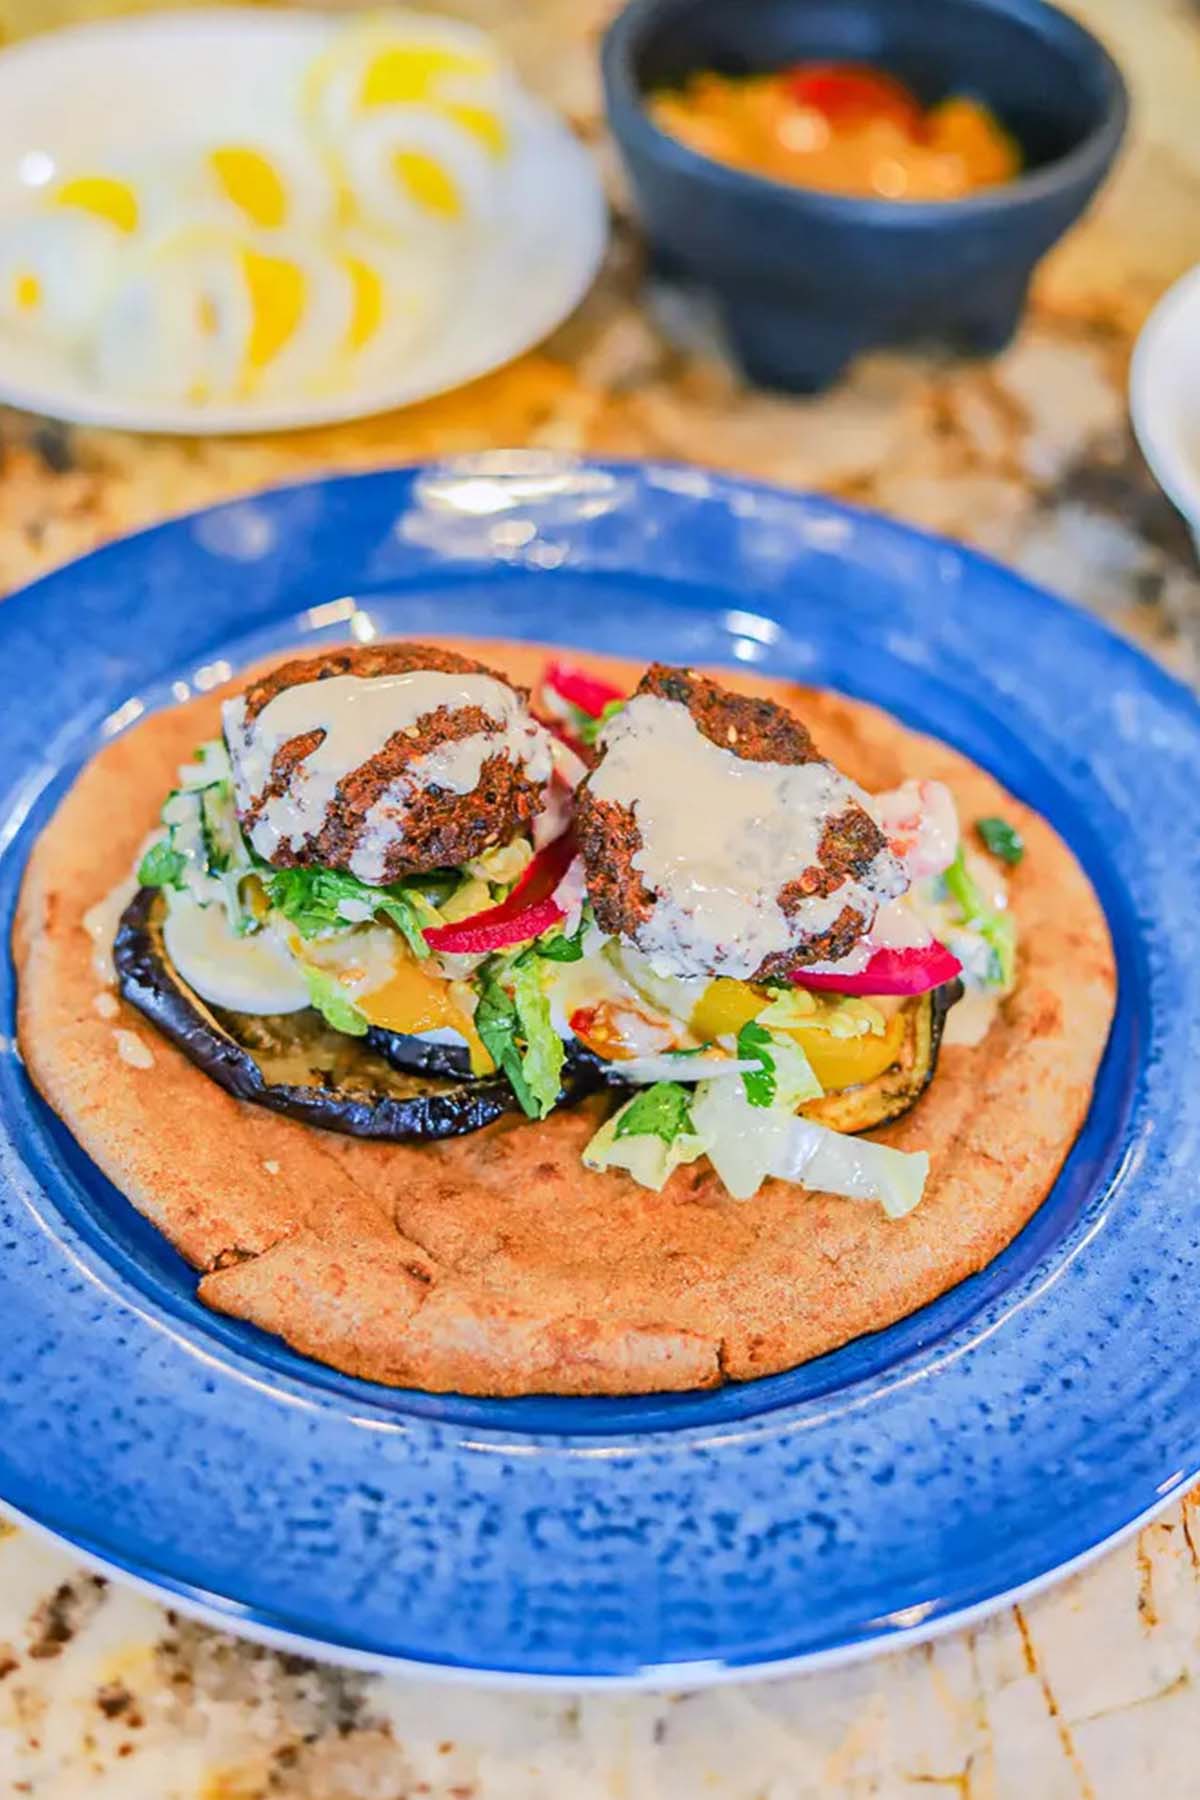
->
[223,670,551,880]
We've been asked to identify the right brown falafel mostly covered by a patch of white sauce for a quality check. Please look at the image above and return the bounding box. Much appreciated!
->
[576,662,907,981]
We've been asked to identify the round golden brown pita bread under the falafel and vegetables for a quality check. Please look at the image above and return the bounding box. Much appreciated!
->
[14,643,1115,1395]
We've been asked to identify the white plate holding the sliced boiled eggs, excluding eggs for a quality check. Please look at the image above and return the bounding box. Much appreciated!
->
[0,7,608,434]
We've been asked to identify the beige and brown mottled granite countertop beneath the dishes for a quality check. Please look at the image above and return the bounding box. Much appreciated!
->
[0,0,1200,1800]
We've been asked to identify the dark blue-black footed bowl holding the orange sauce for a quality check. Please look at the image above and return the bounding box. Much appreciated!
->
[604,0,1128,392]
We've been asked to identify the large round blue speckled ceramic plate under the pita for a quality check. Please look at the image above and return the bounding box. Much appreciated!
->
[0,454,1200,1683]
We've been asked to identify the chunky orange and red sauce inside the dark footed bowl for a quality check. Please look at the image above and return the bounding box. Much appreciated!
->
[649,63,1020,200]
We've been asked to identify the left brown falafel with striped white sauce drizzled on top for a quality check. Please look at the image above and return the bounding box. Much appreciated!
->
[223,643,551,886]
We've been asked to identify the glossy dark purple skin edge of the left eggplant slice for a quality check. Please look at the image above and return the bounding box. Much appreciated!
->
[113,887,516,1143]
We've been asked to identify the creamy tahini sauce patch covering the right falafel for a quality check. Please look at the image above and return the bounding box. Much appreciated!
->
[590,695,905,981]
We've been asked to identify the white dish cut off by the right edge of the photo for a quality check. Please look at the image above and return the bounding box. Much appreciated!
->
[1130,265,1200,554]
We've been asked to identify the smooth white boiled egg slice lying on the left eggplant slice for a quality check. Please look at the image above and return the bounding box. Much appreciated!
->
[162,893,309,1013]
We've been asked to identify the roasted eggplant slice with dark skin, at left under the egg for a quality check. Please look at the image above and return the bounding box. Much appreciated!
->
[113,887,528,1143]
